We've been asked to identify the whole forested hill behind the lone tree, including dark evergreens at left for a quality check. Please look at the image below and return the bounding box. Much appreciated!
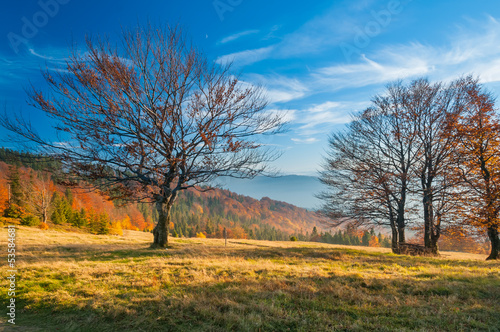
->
[0,149,321,240]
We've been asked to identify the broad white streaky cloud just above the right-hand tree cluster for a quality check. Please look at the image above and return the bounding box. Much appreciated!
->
[312,17,500,90]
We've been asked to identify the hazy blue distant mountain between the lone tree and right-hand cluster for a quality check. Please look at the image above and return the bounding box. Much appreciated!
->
[216,175,324,210]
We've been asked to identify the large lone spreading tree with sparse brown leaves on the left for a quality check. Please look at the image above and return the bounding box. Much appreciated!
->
[2,25,283,247]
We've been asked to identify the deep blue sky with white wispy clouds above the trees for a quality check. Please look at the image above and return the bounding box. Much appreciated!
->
[0,0,500,175]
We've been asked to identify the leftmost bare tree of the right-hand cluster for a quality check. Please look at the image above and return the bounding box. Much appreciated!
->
[320,83,418,252]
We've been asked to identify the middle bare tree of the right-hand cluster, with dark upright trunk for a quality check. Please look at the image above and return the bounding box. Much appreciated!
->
[405,76,474,254]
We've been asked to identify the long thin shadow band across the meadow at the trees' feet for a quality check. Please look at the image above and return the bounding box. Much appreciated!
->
[9,242,495,267]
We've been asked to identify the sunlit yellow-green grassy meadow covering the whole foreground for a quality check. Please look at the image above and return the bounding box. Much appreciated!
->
[0,227,500,331]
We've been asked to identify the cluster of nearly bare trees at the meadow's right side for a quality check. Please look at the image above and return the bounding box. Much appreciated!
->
[320,77,500,259]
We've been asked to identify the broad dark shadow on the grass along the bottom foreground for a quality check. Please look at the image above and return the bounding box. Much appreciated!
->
[9,275,500,331]
